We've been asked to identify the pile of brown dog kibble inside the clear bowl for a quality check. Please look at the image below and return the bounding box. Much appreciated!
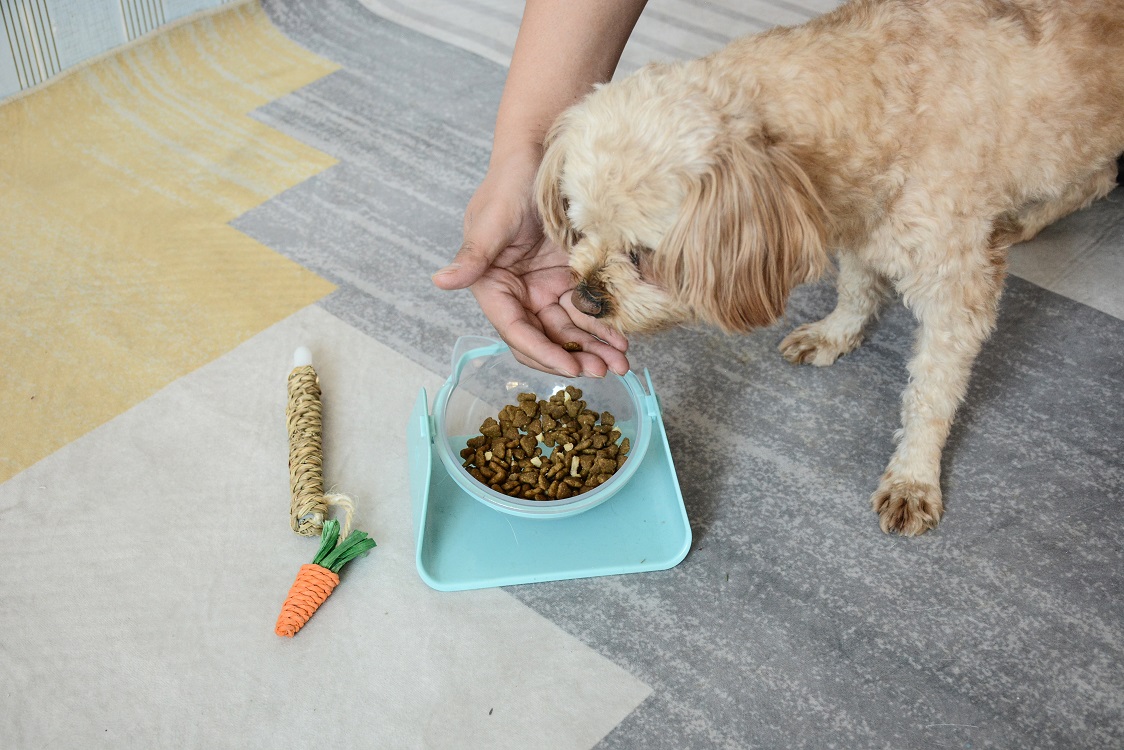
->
[461,384,629,500]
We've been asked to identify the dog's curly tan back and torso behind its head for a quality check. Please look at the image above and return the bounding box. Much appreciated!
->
[700,0,1124,229]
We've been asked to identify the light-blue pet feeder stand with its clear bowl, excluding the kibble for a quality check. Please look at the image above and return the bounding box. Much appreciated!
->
[407,337,691,590]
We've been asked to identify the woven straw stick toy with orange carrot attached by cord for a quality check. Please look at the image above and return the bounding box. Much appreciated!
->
[274,346,374,638]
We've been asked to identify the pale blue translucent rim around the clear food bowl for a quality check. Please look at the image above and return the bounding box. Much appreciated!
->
[433,342,653,518]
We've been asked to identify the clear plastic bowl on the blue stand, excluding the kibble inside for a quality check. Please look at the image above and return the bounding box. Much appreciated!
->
[433,336,652,518]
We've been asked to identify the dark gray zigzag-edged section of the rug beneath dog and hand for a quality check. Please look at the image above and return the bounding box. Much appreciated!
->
[241,0,1124,750]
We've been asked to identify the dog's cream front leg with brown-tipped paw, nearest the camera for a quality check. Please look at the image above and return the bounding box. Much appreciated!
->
[870,222,1006,536]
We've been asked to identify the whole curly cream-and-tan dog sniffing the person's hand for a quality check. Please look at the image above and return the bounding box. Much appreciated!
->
[536,0,1124,535]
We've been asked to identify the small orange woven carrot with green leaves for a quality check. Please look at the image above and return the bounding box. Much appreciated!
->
[273,518,374,638]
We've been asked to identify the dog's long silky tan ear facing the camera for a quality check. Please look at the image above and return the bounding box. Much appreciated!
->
[654,136,827,332]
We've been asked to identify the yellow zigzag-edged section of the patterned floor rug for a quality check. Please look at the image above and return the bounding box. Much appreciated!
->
[0,2,337,482]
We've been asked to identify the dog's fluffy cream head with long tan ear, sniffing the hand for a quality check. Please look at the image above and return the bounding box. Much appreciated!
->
[536,65,826,333]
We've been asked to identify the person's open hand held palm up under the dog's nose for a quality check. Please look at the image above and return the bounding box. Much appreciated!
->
[433,148,628,378]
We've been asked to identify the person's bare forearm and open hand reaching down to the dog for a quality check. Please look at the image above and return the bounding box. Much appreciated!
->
[433,0,644,377]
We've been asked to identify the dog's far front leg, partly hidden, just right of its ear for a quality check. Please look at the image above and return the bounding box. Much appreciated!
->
[779,253,888,367]
